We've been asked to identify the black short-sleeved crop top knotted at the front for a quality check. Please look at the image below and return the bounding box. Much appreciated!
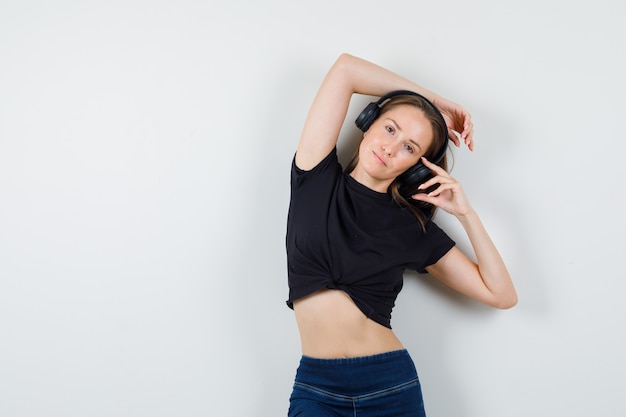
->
[286,149,454,328]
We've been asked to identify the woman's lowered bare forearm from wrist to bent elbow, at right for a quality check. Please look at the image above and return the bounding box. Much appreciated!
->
[457,210,517,308]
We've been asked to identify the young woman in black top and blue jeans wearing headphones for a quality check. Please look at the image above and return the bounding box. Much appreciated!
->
[286,54,517,417]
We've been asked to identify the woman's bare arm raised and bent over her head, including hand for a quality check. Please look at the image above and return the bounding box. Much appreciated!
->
[296,54,473,170]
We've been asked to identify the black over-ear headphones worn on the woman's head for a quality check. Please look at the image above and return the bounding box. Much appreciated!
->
[354,90,448,197]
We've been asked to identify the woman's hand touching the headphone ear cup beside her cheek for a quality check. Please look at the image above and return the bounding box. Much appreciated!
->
[413,157,473,217]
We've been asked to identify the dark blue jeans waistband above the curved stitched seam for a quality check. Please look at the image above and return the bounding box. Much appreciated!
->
[296,349,417,395]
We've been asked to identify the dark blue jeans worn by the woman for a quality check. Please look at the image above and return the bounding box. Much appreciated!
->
[289,350,426,417]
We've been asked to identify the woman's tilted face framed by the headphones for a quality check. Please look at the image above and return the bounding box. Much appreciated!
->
[350,105,433,192]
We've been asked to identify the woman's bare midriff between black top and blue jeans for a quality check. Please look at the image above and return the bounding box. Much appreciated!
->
[293,290,404,358]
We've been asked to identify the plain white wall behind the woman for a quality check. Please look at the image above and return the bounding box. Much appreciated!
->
[0,0,626,417]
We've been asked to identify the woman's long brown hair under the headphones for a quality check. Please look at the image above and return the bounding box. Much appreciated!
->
[345,95,448,228]
